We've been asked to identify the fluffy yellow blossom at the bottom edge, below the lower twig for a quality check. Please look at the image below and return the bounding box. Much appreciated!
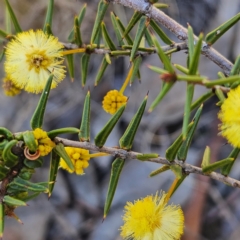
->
[120,192,184,240]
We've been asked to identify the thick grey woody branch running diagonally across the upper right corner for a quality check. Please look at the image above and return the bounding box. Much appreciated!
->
[110,0,233,76]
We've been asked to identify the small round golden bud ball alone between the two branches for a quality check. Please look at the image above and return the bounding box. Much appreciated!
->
[102,90,128,114]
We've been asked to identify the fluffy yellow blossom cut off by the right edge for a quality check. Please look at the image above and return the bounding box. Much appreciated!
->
[218,86,240,148]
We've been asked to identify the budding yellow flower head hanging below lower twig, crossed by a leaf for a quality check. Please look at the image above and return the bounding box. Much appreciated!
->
[60,147,90,175]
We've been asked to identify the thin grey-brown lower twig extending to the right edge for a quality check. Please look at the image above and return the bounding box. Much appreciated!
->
[55,137,240,188]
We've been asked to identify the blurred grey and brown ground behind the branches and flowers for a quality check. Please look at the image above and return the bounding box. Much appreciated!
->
[0,0,240,240]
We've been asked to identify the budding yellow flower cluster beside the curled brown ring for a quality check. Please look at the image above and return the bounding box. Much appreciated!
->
[33,128,55,156]
